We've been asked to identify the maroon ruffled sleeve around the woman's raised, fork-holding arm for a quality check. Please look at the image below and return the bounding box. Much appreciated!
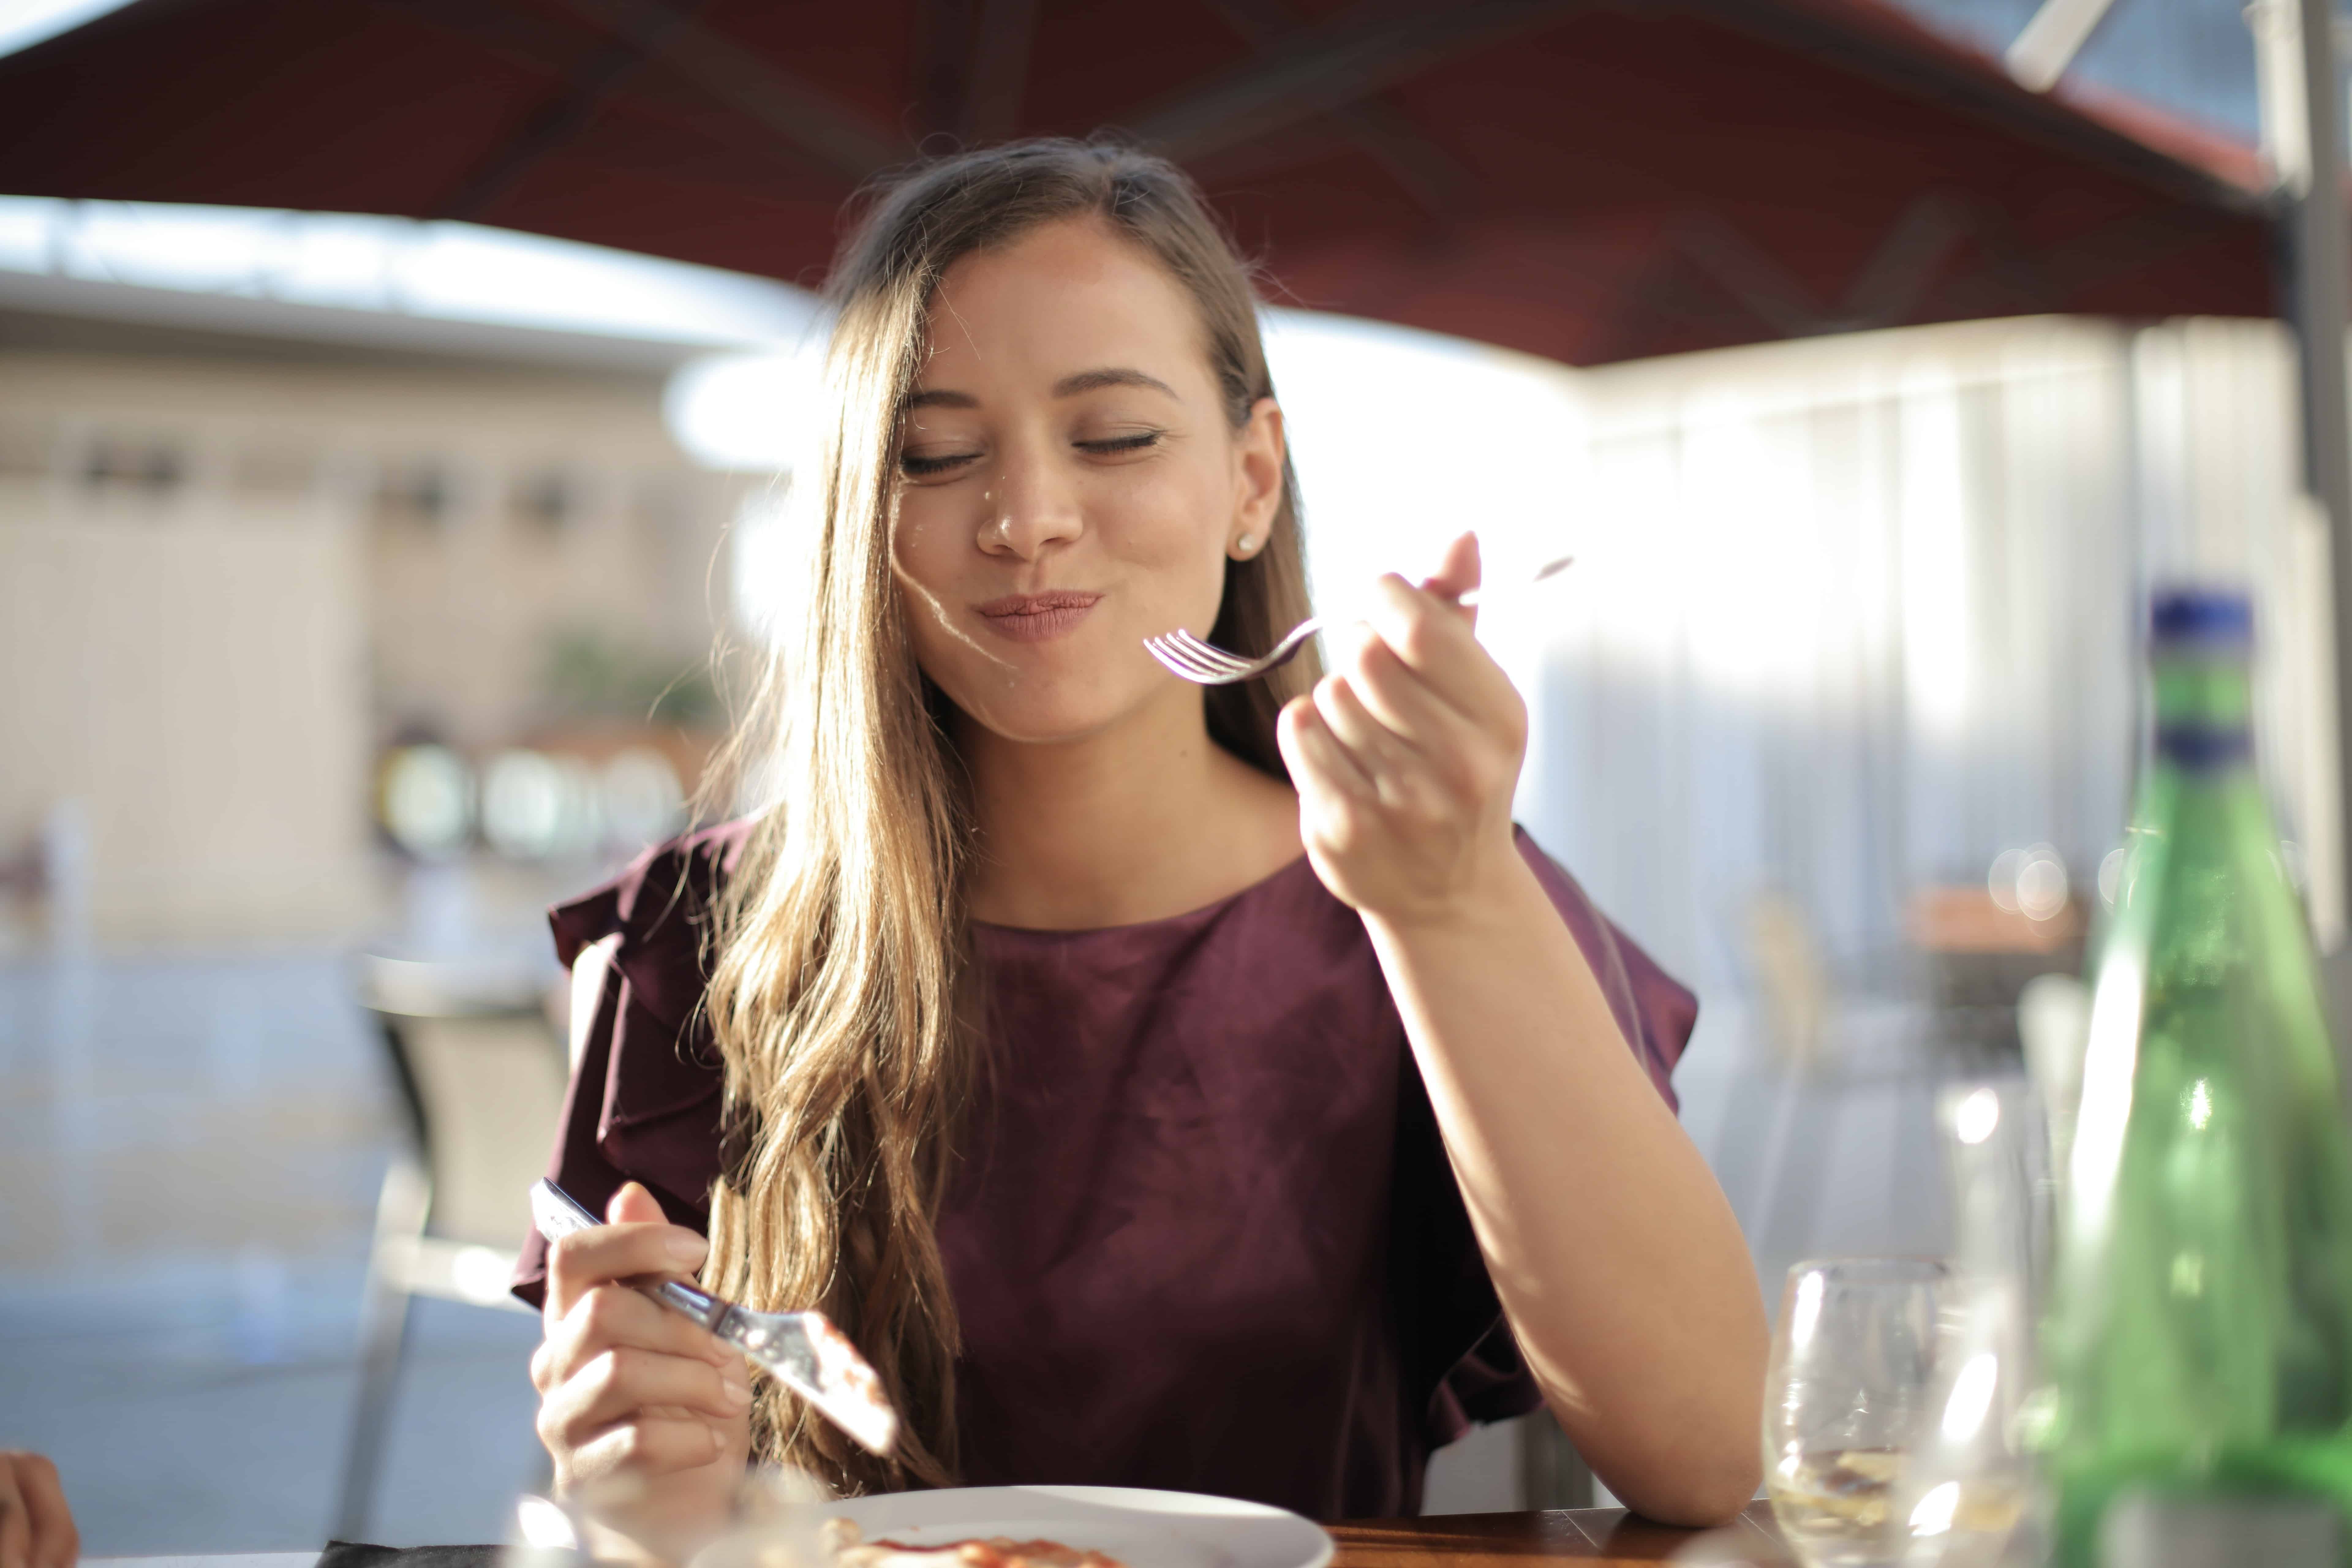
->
[1393,830,1698,1448]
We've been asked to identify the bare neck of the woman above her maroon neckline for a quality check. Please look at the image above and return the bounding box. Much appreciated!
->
[957,686,1298,931]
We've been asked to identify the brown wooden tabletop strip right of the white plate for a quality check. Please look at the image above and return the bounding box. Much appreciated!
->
[1331,1502,1790,1568]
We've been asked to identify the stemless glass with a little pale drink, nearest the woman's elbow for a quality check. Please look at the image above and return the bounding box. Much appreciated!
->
[1764,1258,1950,1568]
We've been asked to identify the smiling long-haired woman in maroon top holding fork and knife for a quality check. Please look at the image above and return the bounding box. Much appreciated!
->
[518,141,1764,1561]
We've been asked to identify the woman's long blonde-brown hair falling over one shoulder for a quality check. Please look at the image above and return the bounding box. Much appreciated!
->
[706,139,1315,1491]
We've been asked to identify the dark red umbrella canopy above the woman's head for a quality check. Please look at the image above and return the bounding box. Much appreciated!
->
[0,0,2272,364]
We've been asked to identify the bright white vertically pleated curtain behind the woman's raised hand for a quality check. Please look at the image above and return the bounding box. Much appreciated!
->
[1270,317,2340,1018]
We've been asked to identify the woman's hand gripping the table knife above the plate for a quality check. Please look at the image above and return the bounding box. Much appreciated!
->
[532,1182,750,1561]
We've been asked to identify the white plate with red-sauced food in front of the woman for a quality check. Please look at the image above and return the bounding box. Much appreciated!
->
[823,1486,1331,1568]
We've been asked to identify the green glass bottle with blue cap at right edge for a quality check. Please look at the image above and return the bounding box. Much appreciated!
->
[2039,592,2352,1568]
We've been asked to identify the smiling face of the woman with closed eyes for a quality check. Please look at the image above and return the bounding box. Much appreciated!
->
[891,219,1282,741]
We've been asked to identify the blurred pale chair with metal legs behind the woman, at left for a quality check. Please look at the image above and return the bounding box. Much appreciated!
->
[334,957,567,1540]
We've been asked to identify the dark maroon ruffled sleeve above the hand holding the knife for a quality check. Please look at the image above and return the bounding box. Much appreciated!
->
[513,823,750,1307]
